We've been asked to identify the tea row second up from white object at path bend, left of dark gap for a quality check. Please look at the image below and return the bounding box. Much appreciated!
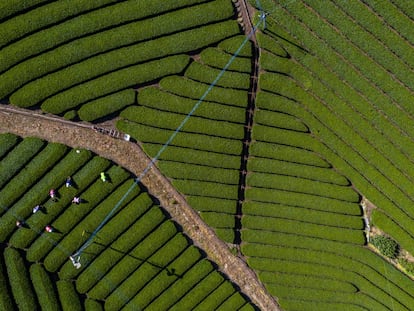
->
[121,106,244,140]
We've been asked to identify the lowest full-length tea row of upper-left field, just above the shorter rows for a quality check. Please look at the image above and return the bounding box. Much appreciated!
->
[10,21,238,107]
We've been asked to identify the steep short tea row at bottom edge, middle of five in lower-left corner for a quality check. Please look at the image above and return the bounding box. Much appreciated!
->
[30,264,59,310]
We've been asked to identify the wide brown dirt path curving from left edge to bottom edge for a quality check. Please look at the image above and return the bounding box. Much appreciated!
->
[0,105,280,311]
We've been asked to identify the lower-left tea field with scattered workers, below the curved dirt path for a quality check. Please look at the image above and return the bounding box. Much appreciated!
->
[0,134,255,310]
